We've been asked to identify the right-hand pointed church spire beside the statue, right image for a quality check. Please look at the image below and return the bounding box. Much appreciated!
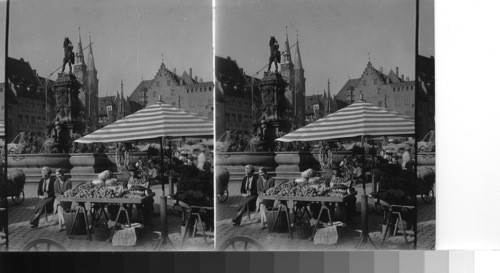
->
[294,34,306,128]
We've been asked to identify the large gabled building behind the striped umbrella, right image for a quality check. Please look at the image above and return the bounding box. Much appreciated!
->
[335,61,416,118]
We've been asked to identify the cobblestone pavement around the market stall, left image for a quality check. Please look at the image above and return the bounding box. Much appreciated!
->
[9,183,214,251]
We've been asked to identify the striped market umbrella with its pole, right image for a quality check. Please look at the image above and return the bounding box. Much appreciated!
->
[277,99,415,248]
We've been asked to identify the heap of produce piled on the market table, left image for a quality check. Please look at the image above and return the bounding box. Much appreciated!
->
[64,182,146,198]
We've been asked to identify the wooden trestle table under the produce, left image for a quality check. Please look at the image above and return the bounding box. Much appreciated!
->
[57,196,150,241]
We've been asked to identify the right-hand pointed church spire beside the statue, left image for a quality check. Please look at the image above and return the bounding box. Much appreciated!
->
[86,35,99,131]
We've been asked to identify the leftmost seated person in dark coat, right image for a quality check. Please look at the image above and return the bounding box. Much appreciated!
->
[233,165,258,226]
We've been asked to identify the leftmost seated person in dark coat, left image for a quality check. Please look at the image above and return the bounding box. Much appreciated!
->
[30,166,55,228]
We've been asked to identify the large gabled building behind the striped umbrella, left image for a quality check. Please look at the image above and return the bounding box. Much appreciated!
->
[128,62,214,119]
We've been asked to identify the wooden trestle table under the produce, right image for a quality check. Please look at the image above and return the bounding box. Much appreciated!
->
[259,192,357,240]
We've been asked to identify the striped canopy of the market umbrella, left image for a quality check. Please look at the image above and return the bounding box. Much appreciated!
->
[76,102,214,143]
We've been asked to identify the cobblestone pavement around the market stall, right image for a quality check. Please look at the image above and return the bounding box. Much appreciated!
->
[216,182,435,251]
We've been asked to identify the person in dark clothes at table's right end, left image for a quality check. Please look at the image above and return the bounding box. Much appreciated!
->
[127,165,154,226]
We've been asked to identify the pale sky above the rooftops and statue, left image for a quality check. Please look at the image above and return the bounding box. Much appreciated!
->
[9,0,213,96]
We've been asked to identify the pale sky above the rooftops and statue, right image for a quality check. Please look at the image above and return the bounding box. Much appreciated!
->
[214,0,416,95]
